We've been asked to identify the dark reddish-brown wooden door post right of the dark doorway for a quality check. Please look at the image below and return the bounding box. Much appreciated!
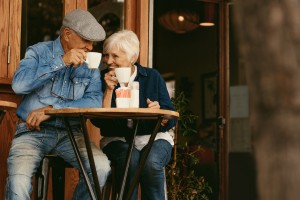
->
[197,0,230,200]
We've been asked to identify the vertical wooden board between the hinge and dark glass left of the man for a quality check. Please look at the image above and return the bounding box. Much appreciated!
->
[7,0,22,78]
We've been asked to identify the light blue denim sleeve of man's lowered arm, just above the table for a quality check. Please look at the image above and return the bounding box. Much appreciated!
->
[52,70,103,109]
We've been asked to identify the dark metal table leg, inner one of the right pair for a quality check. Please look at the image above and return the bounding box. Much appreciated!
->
[116,120,139,200]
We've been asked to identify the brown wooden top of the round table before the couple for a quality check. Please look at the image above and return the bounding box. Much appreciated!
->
[45,108,179,119]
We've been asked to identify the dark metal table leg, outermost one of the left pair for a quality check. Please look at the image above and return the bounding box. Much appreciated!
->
[62,117,97,200]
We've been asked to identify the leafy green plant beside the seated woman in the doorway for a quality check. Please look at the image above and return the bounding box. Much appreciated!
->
[166,92,212,200]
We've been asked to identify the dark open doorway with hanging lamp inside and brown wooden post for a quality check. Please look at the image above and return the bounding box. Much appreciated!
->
[149,0,229,200]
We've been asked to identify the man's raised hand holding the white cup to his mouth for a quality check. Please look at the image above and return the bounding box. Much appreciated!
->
[61,49,86,67]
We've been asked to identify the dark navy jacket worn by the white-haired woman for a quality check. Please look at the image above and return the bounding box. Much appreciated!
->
[91,63,177,137]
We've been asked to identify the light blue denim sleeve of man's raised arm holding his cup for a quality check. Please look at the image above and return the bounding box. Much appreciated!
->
[12,47,66,95]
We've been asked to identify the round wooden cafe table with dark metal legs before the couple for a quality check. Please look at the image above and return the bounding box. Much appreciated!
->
[45,108,179,200]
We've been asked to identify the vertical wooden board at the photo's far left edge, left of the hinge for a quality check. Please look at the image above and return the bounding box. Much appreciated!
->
[0,0,9,78]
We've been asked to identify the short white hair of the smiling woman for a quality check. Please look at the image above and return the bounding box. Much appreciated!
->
[103,30,140,63]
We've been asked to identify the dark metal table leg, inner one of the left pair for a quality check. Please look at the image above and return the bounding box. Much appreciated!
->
[79,115,102,200]
